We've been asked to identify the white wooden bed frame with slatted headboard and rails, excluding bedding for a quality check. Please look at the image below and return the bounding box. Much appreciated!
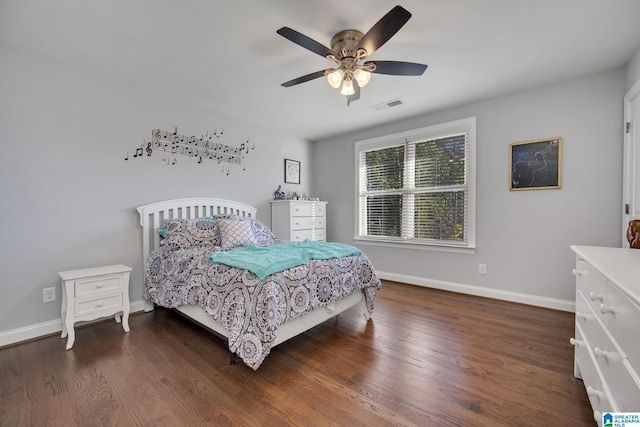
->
[137,198,377,369]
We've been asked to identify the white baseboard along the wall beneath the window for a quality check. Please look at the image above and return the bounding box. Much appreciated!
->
[377,271,576,313]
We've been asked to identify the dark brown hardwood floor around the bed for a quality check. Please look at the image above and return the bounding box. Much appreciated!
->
[0,282,596,427]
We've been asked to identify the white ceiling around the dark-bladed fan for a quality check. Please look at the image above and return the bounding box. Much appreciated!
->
[0,0,640,140]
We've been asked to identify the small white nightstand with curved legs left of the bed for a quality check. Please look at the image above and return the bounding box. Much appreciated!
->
[58,264,131,350]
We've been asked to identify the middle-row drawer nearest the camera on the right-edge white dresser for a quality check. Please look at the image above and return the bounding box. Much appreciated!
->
[592,322,640,411]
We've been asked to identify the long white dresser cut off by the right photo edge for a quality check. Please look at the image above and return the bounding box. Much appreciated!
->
[571,246,640,426]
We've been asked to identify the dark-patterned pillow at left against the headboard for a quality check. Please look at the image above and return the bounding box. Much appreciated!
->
[163,219,220,249]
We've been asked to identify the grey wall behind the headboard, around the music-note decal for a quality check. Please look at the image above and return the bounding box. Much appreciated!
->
[0,42,312,341]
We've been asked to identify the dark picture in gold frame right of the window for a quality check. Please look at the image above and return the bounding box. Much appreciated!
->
[509,137,562,191]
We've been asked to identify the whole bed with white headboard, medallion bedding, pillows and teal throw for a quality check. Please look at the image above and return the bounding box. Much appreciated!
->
[137,198,381,369]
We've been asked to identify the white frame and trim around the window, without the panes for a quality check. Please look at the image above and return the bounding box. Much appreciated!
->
[354,117,476,253]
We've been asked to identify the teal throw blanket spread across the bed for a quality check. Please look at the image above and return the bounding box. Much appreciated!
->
[209,240,362,280]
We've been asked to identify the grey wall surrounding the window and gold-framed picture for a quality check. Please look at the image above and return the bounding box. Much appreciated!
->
[313,69,624,309]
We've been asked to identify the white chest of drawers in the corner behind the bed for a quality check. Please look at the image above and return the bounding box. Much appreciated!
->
[271,200,327,242]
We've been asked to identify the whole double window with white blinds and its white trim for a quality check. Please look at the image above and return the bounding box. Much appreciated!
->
[356,117,476,249]
